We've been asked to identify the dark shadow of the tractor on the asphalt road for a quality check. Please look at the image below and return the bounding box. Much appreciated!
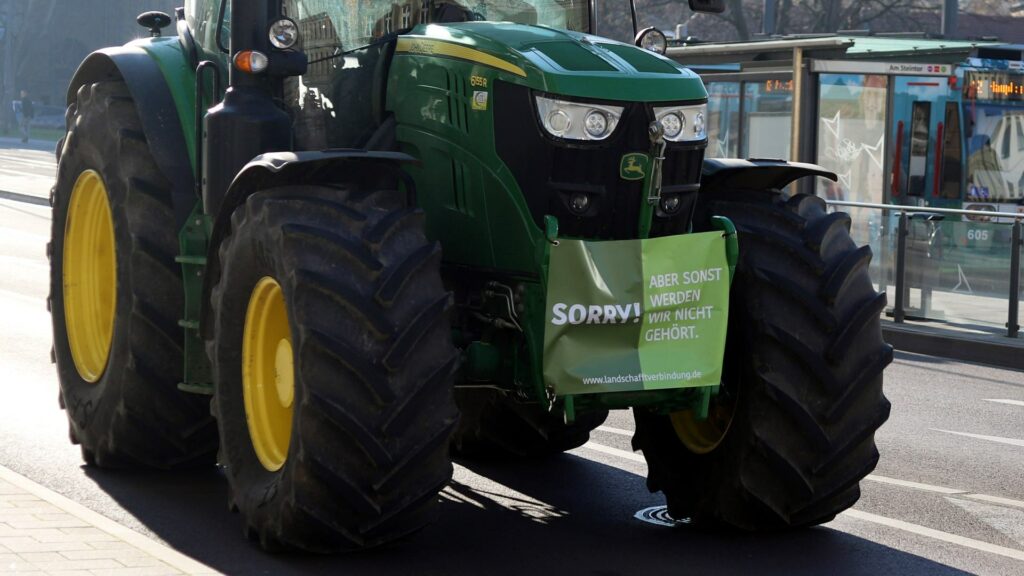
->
[79,454,964,576]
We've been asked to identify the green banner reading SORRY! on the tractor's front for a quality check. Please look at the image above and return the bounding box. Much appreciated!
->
[544,232,729,396]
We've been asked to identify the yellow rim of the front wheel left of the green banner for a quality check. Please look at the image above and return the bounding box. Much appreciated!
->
[242,277,295,471]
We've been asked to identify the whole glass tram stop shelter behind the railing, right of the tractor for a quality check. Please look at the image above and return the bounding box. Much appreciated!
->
[668,35,1024,366]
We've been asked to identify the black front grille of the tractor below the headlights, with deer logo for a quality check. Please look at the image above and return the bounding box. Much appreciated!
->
[494,82,705,240]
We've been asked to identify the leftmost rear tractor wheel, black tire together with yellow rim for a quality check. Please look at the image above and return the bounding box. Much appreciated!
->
[49,81,217,468]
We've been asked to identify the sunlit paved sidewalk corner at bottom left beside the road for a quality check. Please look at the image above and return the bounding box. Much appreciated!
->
[0,466,218,576]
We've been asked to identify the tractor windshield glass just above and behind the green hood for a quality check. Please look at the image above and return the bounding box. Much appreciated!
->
[284,0,590,50]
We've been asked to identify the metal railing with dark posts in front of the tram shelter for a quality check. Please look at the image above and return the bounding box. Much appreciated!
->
[825,200,1024,338]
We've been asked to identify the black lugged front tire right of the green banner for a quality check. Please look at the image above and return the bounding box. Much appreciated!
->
[633,191,892,530]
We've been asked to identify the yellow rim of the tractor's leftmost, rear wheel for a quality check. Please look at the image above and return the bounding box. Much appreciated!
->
[63,170,118,382]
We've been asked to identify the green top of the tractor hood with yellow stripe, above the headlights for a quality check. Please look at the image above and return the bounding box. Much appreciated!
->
[399,23,708,101]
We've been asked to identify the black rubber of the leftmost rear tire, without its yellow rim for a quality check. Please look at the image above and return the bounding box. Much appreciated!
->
[49,81,217,468]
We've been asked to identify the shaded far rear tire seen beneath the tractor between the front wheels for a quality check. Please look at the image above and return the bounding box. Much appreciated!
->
[452,388,608,458]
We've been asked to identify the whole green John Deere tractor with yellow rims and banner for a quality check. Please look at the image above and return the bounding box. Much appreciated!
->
[50,0,892,551]
